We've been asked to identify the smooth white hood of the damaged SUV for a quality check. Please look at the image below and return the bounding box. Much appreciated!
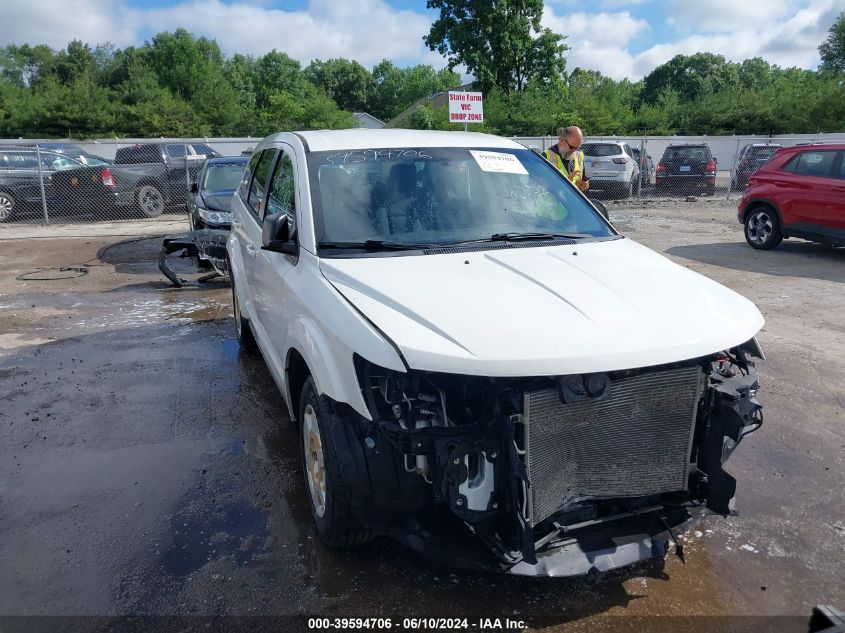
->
[320,238,764,376]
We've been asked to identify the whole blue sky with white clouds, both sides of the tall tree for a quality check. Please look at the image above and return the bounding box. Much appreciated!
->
[0,0,845,80]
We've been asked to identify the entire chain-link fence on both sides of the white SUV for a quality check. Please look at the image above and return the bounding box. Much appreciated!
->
[0,134,845,226]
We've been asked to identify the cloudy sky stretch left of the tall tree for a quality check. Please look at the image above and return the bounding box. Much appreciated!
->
[0,0,436,67]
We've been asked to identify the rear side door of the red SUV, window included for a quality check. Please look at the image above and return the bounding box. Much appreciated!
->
[772,149,838,233]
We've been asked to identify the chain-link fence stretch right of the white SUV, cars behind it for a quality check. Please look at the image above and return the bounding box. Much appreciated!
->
[514,134,845,199]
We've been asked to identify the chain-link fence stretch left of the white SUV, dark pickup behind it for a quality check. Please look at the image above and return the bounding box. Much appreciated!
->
[0,138,260,225]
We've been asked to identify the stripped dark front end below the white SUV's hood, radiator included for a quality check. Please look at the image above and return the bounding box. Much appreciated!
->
[331,340,763,576]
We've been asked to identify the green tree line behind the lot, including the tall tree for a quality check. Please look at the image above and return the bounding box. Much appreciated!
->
[0,7,845,139]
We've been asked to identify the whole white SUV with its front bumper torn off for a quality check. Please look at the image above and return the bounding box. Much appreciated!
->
[227,130,763,576]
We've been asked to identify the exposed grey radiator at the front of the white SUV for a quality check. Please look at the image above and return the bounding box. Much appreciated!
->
[524,366,701,525]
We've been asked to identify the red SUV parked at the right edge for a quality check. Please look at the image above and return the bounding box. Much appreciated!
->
[737,144,845,250]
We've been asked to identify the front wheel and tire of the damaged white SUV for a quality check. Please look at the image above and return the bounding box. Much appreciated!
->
[299,376,373,549]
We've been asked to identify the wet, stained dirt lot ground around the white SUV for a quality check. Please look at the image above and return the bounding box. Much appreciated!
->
[0,200,845,631]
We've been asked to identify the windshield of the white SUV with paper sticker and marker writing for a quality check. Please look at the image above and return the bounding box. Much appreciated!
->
[308,148,614,245]
